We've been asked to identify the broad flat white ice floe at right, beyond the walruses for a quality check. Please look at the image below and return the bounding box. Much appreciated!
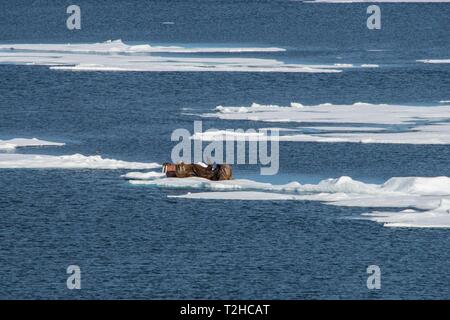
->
[205,102,450,144]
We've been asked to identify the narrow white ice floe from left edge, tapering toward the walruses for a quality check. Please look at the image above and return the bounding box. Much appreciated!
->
[0,153,160,170]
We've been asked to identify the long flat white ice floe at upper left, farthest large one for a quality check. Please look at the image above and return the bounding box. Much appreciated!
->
[0,40,342,73]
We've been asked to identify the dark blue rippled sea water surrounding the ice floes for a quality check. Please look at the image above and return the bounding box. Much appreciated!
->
[0,0,450,299]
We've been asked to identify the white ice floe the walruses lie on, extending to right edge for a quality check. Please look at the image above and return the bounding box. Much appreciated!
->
[129,177,450,227]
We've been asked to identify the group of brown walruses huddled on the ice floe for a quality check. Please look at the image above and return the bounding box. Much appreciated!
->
[163,162,233,181]
